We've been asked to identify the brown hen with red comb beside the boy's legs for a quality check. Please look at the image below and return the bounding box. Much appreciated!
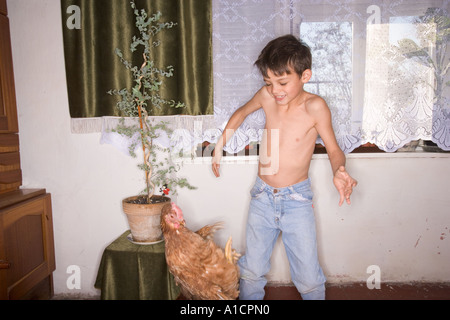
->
[161,203,239,300]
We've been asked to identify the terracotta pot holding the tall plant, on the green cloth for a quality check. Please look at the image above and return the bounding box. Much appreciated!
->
[122,196,171,243]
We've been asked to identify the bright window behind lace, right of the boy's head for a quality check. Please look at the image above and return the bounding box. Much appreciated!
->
[292,1,450,153]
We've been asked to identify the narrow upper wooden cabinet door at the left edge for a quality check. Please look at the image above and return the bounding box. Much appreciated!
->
[0,9,19,133]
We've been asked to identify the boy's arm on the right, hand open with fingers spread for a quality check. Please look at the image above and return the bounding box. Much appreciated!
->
[308,98,358,206]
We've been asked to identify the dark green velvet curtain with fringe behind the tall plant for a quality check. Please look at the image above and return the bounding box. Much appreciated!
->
[61,0,213,118]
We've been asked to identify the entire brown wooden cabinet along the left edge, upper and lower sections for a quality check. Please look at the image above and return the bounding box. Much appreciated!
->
[0,0,55,300]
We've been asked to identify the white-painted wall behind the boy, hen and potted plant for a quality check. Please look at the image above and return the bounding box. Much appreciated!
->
[7,0,450,295]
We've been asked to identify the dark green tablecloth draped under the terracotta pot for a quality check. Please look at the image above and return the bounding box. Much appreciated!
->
[94,231,180,300]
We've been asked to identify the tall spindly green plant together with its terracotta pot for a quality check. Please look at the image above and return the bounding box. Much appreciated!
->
[108,1,194,243]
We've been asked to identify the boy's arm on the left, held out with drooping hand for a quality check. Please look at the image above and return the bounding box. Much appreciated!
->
[212,87,264,177]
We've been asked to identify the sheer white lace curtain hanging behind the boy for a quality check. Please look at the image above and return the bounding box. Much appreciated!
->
[210,0,450,153]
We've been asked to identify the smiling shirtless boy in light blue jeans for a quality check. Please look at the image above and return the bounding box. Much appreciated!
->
[212,35,357,300]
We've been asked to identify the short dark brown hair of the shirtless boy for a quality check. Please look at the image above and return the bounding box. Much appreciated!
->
[255,34,312,78]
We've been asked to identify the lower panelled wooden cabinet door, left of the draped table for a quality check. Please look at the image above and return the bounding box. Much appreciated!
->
[0,194,55,300]
